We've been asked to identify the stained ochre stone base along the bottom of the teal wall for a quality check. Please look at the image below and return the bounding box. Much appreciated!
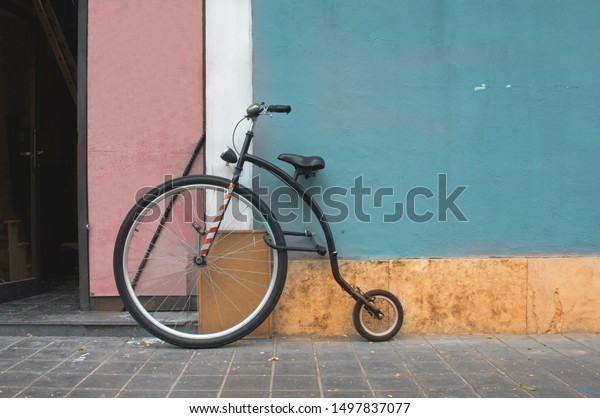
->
[273,257,600,336]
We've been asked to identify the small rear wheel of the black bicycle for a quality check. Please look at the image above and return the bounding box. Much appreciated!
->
[352,289,404,342]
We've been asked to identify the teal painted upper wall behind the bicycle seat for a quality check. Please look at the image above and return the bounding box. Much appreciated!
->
[253,0,600,258]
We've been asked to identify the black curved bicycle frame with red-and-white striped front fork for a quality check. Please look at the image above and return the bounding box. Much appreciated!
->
[200,115,383,318]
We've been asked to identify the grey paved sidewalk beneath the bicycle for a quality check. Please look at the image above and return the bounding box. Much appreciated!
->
[0,334,600,398]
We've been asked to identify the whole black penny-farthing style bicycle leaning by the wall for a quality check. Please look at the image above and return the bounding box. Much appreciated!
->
[113,103,404,348]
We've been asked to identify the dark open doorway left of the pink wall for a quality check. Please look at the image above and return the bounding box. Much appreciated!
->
[0,0,79,301]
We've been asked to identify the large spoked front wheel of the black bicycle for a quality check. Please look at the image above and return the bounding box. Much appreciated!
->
[113,176,287,348]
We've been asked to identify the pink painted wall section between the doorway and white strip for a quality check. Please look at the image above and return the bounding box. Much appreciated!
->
[88,0,204,296]
